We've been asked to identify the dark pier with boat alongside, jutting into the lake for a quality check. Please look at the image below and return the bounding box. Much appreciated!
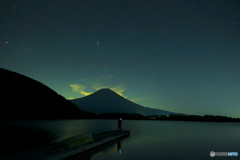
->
[0,130,130,160]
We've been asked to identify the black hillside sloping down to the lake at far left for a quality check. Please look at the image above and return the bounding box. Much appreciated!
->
[0,68,93,119]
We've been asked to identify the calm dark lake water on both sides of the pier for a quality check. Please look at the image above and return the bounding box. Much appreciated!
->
[0,120,240,160]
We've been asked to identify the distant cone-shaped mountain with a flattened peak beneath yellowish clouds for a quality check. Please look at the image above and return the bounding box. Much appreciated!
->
[70,88,174,115]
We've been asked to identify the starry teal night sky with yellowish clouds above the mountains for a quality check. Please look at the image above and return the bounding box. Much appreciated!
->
[0,0,240,117]
